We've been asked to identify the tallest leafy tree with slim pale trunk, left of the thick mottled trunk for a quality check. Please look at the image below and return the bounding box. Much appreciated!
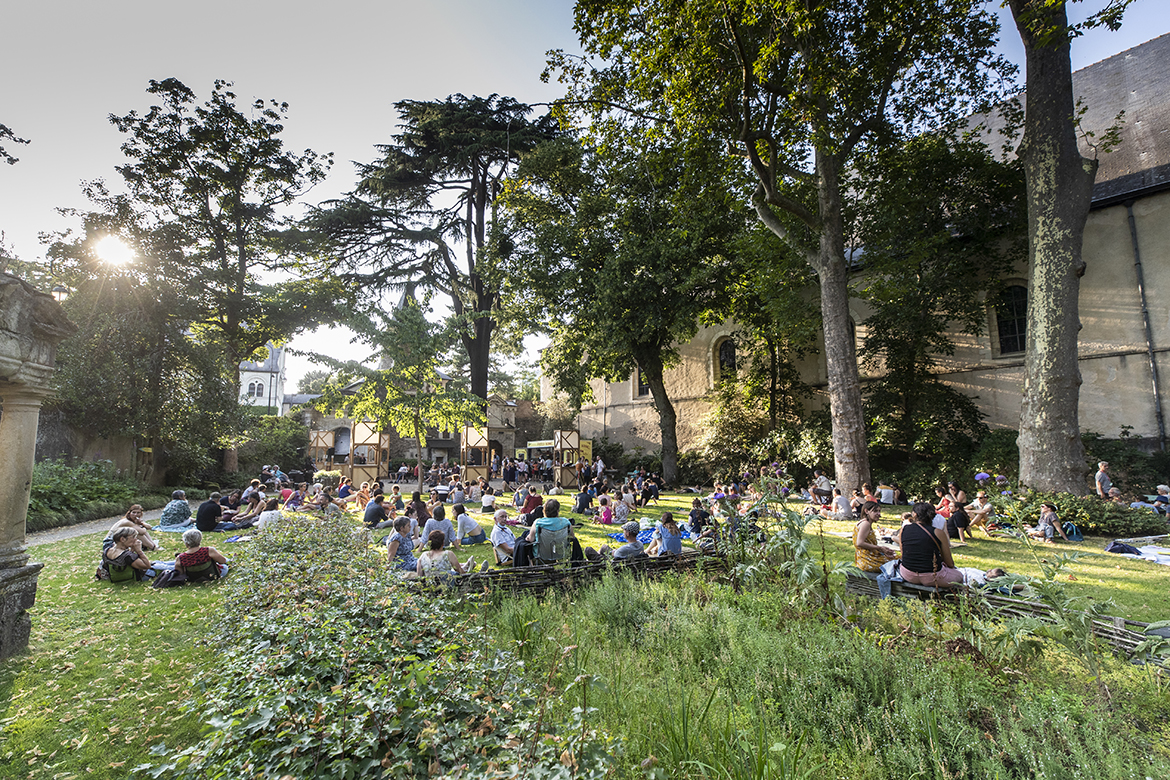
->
[551,0,1009,486]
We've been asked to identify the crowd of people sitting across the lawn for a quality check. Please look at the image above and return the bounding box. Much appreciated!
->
[99,458,1170,585]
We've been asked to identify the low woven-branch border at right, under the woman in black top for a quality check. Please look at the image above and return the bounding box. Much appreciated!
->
[845,572,1170,668]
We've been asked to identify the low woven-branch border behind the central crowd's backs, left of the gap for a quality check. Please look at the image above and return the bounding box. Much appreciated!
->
[444,552,728,596]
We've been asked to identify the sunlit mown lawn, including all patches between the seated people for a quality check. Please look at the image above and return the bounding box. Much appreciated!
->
[0,493,1170,780]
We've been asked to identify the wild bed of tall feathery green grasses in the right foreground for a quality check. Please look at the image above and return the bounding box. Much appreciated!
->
[489,577,1170,780]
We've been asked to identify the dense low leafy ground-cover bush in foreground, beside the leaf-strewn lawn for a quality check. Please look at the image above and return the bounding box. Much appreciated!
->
[138,516,612,780]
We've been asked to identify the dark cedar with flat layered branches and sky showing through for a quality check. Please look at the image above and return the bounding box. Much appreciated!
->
[308,95,557,409]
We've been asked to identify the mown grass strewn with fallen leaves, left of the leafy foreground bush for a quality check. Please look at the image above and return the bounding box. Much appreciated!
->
[0,534,219,780]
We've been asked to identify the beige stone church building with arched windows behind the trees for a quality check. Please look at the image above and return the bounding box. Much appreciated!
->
[552,35,1170,449]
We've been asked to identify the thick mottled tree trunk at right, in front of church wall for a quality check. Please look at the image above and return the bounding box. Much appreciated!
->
[1011,0,1096,493]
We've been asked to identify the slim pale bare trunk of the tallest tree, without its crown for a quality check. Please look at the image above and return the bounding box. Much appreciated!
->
[813,153,869,495]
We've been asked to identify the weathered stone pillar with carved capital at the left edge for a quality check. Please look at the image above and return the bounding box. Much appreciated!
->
[0,272,76,658]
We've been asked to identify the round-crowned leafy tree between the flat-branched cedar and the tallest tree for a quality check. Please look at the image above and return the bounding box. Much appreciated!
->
[505,138,745,484]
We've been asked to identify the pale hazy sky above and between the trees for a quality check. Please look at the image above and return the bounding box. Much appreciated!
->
[0,0,1170,391]
